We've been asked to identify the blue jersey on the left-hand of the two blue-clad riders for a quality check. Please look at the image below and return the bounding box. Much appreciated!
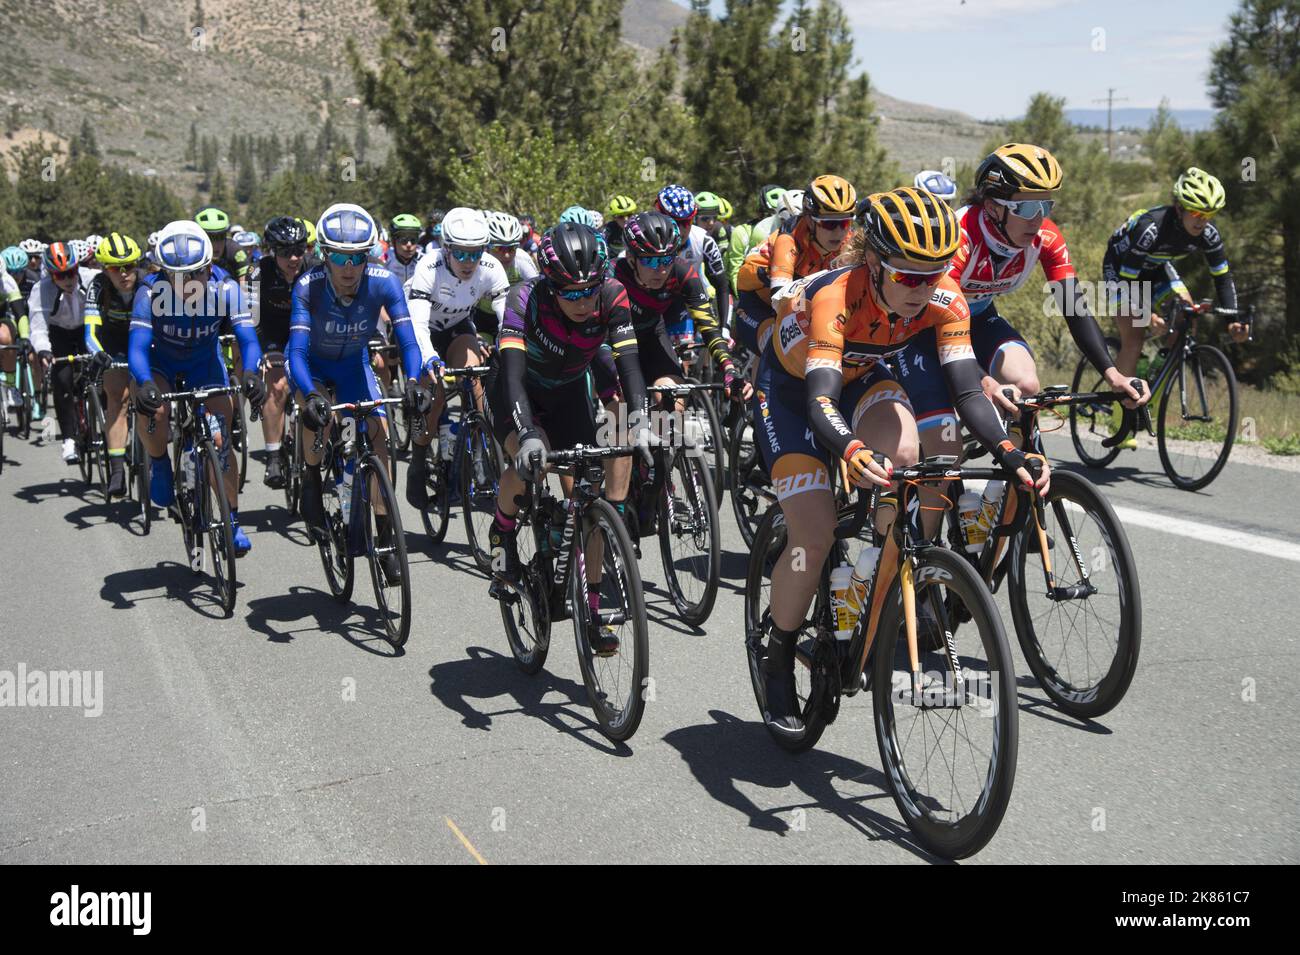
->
[127,268,261,383]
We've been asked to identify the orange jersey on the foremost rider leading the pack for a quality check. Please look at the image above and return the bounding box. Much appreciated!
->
[772,265,975,383]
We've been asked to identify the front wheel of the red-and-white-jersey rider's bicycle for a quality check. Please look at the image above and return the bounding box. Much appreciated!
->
[1008,470,1141,720]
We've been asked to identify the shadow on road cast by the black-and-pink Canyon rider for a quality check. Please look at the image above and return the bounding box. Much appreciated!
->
[429,647,632,756]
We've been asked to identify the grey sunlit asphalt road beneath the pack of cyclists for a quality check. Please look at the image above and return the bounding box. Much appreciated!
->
[0,420,1300,864]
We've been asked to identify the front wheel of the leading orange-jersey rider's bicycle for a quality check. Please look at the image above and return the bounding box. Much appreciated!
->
[871,547,1019,859]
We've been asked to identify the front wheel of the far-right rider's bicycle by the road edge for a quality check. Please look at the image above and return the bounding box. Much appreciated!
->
[1156,344,1239,491]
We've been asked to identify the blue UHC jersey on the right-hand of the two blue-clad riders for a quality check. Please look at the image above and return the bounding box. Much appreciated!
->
[285,264,420,395]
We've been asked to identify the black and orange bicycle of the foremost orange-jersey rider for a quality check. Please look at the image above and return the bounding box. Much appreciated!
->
[745,457,1037,859]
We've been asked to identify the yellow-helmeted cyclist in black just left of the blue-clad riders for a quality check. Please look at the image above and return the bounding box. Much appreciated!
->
[85,233,142,498]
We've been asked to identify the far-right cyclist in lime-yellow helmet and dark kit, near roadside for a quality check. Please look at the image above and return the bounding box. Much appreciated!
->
[1101,166,1251,448]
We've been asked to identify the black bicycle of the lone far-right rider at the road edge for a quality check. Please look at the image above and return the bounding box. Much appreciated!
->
[1070,299,1255,491]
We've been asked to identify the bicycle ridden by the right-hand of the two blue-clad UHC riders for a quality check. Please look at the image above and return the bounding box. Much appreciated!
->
[309,398,419,647]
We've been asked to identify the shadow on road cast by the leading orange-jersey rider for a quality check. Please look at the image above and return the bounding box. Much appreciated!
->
[663,709,943,863]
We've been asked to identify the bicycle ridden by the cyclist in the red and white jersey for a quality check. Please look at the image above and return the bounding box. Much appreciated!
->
[948,385,1141,720]
